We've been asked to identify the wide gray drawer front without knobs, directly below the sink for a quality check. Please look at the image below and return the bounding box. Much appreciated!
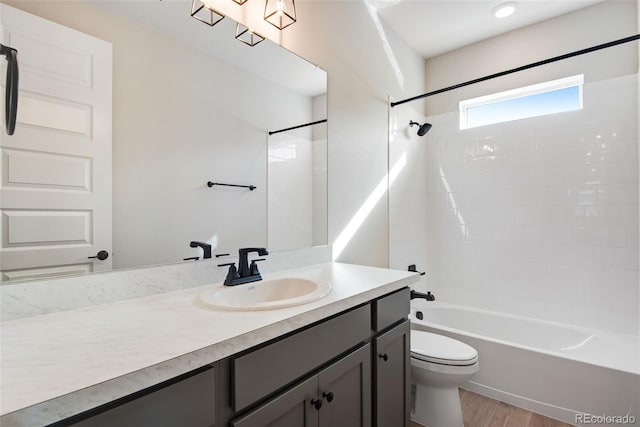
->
[231,305,371,411]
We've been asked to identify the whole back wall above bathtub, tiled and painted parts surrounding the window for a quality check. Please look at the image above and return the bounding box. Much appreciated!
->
[391,2,640,334]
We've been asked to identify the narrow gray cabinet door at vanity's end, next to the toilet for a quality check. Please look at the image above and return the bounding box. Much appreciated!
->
[374,320,411,427]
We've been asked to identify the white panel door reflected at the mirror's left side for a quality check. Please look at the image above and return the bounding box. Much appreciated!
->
[0,4,112,280]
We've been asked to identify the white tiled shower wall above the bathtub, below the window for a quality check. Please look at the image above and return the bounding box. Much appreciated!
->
[418,75,640,334]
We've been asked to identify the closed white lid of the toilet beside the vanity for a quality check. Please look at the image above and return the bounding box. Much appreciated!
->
[411,330,478,366]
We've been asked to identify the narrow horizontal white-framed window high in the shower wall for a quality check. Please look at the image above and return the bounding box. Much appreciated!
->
[460,74,584,129]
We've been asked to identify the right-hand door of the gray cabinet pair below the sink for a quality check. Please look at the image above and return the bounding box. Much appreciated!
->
[318,344,372,427]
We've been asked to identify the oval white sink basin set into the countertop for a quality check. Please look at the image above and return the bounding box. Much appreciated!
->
[198,278,331,311]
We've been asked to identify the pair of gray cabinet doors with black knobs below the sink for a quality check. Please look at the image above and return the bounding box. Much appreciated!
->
[231,344,371,427]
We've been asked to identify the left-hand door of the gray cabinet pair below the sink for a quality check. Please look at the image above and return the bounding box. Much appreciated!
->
[231,376,318,427]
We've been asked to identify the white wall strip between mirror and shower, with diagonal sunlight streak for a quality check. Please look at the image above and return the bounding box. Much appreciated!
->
[214,0,425,266]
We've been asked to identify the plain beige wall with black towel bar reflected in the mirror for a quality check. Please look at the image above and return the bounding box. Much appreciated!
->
[7,1,311,268]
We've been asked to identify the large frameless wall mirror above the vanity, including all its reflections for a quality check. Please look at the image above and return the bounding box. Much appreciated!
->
[0,0,327,282]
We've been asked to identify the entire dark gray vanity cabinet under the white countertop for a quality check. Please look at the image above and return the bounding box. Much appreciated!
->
[56,288,410,427]
